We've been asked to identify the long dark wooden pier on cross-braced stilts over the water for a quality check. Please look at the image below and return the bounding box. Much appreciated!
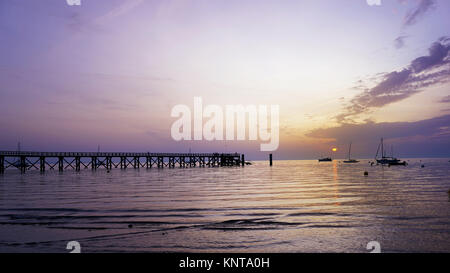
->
[0,151,245,174]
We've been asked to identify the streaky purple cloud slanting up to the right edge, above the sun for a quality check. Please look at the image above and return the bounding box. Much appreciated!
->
[336,37,450,123]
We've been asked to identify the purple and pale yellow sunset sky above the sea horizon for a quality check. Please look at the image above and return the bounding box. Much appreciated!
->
[0,0,450,159]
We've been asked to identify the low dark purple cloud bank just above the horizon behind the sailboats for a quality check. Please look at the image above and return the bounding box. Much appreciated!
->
[307,115,450,157]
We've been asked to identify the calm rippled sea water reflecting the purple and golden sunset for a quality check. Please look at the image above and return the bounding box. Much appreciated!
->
[0,159,450,252]
